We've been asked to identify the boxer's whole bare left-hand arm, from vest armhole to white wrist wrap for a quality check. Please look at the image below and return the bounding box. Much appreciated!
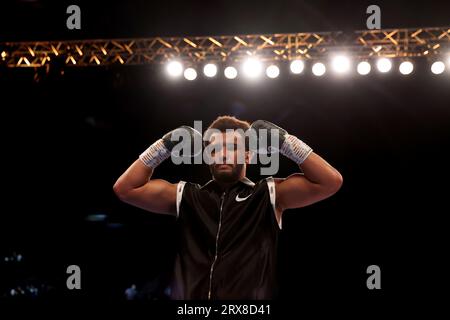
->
[113,159,177,215]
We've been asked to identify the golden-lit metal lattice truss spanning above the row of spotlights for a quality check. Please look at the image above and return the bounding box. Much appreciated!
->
[0,27,450,67]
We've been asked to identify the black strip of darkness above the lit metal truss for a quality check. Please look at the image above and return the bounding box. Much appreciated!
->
[0,0,450,40]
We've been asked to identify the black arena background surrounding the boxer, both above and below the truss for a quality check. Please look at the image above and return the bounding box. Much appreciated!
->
[0,1,450,304]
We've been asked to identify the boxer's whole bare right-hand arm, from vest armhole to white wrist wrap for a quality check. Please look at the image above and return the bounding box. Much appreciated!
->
[275,152,343,215]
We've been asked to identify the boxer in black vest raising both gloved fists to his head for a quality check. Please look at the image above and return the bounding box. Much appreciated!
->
[113,116,343,300]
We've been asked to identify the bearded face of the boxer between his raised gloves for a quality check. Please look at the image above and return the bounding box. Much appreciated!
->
[209,132,249,183]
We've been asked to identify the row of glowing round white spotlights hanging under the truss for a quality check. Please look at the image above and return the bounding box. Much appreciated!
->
[167,56,450,80]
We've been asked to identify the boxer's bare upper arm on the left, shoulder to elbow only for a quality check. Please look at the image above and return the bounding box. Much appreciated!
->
[123,179,178,215]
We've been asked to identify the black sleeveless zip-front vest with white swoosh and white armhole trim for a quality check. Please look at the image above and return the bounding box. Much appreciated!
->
[169,178,280,300]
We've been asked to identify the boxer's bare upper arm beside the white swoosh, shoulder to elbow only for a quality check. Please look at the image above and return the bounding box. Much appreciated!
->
[276,173,330,211]
